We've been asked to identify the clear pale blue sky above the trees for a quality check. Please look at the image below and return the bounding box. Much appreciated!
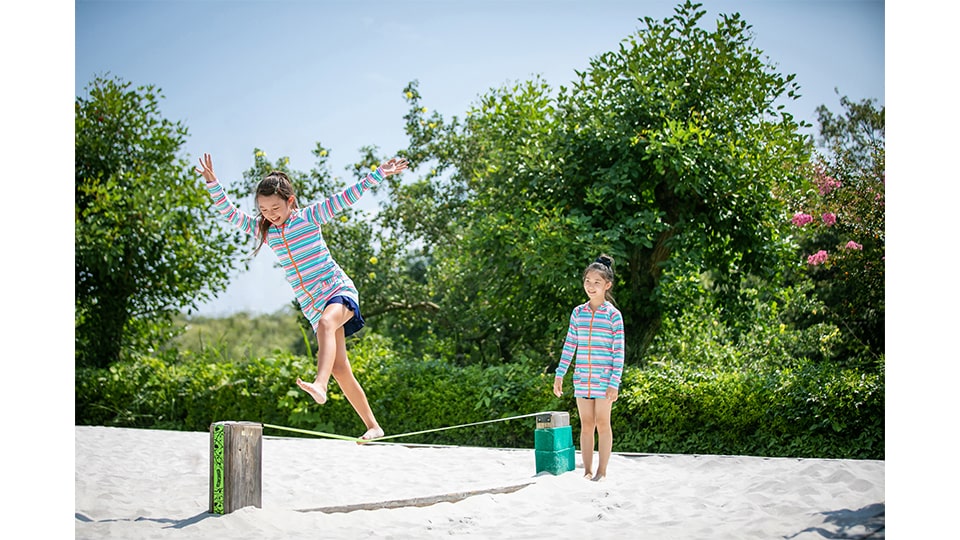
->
[74,0,885,316]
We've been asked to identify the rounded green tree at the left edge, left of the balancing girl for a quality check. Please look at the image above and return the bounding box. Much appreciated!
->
[74,77,244,367]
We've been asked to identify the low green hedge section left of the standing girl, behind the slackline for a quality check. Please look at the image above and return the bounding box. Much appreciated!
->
[76,334,553,447]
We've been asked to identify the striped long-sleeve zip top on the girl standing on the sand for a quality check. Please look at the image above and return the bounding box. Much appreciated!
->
[556,302,624,398]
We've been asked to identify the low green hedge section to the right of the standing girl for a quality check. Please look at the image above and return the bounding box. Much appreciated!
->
[613,363,884,459]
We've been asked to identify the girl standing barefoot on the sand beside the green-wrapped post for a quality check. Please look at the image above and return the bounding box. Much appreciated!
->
[553,255,623,482]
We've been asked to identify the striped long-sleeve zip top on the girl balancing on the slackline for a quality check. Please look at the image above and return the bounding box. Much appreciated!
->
[207,167,384,330]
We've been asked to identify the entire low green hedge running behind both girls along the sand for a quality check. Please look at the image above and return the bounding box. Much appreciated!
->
[76,334,884,459]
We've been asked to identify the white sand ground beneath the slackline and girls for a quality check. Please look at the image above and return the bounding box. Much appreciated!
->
[75,425,885,540]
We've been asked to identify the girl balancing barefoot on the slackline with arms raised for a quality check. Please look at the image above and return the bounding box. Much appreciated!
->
[196,154,407,439]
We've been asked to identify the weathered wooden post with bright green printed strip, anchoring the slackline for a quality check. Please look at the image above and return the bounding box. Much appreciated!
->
[210,421,263,514]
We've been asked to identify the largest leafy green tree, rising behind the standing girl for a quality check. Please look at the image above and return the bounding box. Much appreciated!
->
[382,1,809,361]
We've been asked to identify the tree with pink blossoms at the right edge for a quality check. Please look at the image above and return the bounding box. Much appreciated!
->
[791,97,886,365]
